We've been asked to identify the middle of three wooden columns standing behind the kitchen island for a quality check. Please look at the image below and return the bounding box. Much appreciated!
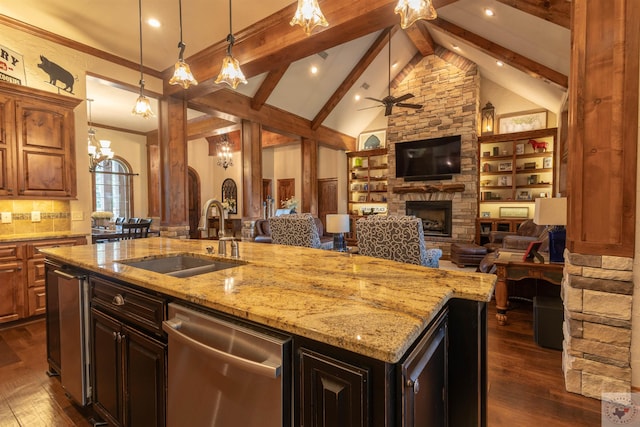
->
[241,120,262,218]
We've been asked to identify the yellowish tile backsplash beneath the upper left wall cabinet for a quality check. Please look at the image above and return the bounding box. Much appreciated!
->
[0,200,71,236]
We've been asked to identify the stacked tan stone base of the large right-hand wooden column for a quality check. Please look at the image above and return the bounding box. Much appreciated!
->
[562,250,633,399]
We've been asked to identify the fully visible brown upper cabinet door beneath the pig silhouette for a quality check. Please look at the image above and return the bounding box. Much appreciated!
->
[16,100,75,197]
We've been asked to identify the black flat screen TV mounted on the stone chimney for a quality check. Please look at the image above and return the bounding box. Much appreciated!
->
[395,135,462,181]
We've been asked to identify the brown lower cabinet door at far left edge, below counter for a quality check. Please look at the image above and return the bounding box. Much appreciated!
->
[0,260,24,322]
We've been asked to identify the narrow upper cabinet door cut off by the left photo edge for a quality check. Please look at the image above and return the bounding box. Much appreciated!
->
[0,95,16,196]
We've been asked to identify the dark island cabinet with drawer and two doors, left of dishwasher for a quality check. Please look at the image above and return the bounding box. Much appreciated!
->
[91,278,167,426]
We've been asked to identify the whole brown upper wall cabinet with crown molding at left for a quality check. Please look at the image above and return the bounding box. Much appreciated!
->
[0,82,80,199]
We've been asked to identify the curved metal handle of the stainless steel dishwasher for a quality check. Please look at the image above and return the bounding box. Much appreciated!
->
[162,320,282,378]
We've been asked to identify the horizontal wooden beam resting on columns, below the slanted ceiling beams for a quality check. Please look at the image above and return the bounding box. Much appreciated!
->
[193,90,356,151]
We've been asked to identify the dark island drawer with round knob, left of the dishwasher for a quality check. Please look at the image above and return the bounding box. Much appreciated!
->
[91,277,166,335]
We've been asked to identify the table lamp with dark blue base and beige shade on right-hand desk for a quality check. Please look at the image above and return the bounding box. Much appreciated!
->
[533,197,567,262]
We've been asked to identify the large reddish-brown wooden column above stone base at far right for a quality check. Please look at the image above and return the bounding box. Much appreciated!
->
[567,0,640,257]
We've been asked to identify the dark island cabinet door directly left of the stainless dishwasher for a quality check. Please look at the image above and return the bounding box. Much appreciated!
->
[123,326,167,426]
